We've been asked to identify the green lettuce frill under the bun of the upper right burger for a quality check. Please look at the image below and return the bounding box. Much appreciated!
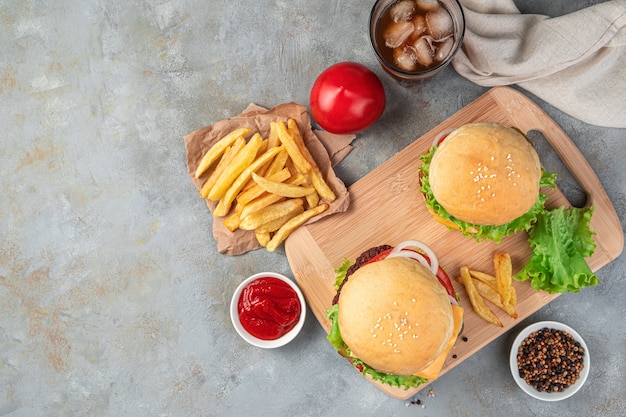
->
[419,146,556,243]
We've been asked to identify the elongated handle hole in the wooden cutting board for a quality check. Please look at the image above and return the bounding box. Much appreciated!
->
[526,130,587,208]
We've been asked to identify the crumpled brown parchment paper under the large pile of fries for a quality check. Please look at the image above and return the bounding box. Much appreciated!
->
[184,102,356,255]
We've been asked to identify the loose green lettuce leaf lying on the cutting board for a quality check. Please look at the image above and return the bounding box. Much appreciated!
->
[514,207,598,294]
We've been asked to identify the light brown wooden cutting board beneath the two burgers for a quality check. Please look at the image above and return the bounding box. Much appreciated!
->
[285,87,624,399]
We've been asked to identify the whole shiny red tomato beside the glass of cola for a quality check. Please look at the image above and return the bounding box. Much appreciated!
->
[310,62,385,134]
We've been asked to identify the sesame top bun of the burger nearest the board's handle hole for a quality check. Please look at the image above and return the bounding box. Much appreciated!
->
[429,123,541,226]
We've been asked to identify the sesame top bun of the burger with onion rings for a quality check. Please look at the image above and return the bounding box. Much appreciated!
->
[338,257,454,375]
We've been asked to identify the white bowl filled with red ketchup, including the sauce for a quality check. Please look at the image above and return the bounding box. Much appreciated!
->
[230,272,306,349]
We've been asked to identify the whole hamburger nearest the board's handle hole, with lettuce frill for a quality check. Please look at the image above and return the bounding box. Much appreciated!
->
[419,122,556,243]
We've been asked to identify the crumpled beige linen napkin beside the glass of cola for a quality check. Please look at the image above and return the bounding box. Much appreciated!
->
[453,0,626,127]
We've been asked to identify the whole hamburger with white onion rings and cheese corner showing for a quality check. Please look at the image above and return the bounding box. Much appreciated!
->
[327,241,463,389]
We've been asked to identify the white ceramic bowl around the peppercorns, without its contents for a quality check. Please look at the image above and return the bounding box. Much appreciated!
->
[509,321,591,401]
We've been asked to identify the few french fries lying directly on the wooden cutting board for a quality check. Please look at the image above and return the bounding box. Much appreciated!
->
[456,253,517,327]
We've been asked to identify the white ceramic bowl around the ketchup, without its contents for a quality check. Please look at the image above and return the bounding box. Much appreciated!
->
[230,272,306,349]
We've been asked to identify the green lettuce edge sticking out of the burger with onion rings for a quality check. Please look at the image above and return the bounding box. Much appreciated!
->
[326,304,428,390]
